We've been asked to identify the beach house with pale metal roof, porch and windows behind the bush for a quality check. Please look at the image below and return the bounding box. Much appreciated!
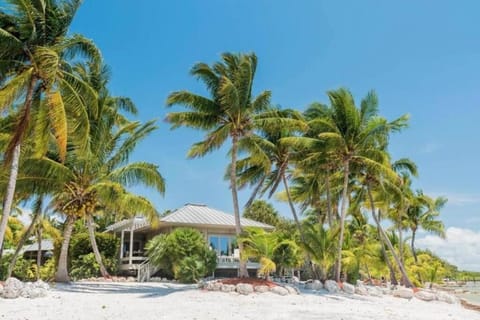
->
[106,204,274,281]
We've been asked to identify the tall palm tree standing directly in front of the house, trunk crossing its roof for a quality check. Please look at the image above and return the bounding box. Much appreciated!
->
[167,53,276,277]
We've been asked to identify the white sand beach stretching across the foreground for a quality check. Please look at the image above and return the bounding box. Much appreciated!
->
[0,283,480,320]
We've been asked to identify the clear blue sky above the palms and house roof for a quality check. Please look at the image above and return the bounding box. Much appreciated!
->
[72,0,480,269]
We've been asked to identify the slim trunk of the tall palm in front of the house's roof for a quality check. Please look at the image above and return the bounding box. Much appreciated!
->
[230,134,248,278]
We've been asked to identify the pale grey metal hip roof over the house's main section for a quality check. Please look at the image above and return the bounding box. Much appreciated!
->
[160,203,274,230]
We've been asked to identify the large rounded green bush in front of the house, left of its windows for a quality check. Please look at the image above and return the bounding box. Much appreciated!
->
[145,228,217,283]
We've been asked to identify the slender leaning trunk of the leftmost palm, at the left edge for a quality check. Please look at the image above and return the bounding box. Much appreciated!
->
[0,77,37,254]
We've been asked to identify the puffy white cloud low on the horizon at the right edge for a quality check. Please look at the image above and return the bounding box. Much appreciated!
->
[416,227,480,271]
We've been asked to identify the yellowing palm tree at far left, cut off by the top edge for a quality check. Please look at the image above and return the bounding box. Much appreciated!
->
[0,0,100,255]
